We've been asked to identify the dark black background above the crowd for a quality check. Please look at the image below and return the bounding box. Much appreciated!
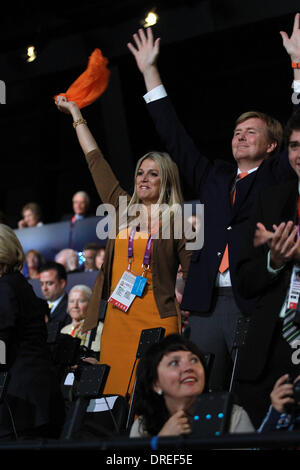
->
[0,0,300,227]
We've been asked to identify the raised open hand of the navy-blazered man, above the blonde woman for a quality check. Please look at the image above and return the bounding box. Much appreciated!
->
[127,28,162,91]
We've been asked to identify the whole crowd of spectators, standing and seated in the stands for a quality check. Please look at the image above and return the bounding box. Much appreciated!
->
[0,14,300,452]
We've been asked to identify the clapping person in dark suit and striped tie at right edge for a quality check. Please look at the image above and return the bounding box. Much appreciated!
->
[235,107,300,425]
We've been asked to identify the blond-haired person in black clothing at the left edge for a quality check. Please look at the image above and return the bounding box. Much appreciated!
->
[0,224,64,439]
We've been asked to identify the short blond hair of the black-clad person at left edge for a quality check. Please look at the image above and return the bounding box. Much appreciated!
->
[0,224,25,274]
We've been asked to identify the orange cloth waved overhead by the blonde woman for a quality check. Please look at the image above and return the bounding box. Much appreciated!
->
[54,49,110,109]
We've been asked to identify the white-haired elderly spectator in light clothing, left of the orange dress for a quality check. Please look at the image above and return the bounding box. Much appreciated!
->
[61,284,103,352]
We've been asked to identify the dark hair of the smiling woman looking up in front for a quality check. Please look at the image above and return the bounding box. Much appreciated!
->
[135,334,206,436]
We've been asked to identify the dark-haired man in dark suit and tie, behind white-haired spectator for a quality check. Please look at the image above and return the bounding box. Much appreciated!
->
[40,261,71,326]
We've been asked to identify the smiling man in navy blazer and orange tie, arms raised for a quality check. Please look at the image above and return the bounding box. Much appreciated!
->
[128,14,300,389]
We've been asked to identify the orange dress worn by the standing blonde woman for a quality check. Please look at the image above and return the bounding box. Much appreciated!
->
[100,229,179,396]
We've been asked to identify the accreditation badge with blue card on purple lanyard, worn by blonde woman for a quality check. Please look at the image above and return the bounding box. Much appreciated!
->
[108,227,153,312]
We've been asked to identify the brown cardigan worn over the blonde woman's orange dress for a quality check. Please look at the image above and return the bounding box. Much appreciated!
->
[83,149,192,331]
